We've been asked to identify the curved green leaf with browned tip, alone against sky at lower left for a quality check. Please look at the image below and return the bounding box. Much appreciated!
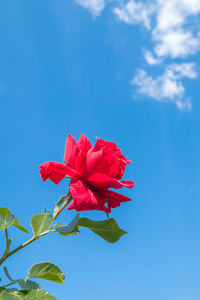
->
[28,262,65,283]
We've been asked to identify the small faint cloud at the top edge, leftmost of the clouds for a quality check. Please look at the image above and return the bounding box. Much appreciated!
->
[75,0,105,17]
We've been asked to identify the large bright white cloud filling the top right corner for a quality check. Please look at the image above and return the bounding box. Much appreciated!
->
[114,0,200,58]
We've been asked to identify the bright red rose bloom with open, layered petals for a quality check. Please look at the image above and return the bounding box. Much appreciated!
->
[39,134,134,213]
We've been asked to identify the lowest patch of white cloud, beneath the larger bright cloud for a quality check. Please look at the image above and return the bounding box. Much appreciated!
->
[131,63,197,110]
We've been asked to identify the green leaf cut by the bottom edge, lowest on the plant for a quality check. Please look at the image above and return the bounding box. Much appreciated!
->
[16,289,57,300]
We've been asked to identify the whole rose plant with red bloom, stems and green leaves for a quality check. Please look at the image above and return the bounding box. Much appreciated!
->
[0,134,134,300]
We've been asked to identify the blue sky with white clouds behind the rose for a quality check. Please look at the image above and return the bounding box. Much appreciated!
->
[0,0,200,300]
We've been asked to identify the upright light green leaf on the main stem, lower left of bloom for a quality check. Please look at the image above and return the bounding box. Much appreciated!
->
[31,213,53,236]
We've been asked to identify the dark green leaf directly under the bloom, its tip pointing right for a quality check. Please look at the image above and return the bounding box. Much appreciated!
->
[79,218,127,243]
